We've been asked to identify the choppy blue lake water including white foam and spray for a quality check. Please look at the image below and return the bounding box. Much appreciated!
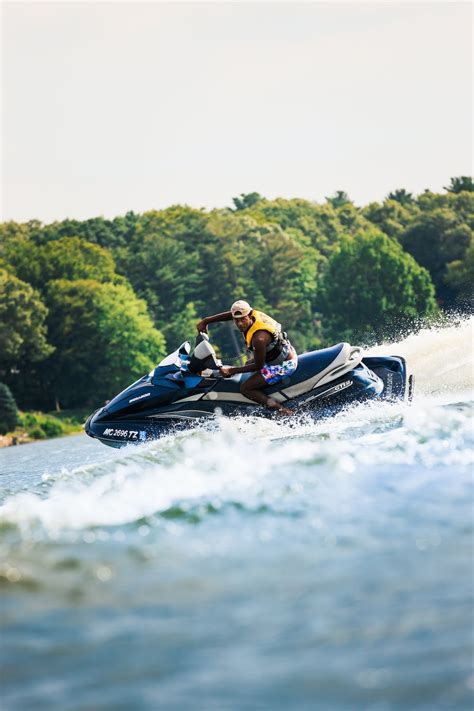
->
[0,322,474,711]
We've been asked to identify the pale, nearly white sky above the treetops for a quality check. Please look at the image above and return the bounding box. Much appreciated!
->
[1,0,472,222]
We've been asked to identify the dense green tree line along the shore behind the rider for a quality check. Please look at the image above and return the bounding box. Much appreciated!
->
[0,176,474,410]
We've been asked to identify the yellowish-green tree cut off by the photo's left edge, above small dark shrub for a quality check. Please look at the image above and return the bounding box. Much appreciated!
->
[0,269,53,376]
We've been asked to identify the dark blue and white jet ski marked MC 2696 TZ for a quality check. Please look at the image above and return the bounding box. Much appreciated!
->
[85,333,413,447]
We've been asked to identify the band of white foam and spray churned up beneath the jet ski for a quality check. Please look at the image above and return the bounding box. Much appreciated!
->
[0,319,473,535]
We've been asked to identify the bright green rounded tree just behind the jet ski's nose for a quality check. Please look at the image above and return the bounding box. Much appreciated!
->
[39,279,165,407]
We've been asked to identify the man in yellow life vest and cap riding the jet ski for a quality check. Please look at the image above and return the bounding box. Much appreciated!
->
[197,300,298,415]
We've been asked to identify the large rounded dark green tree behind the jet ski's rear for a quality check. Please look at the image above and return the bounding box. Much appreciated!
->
[320,228,436,340]
